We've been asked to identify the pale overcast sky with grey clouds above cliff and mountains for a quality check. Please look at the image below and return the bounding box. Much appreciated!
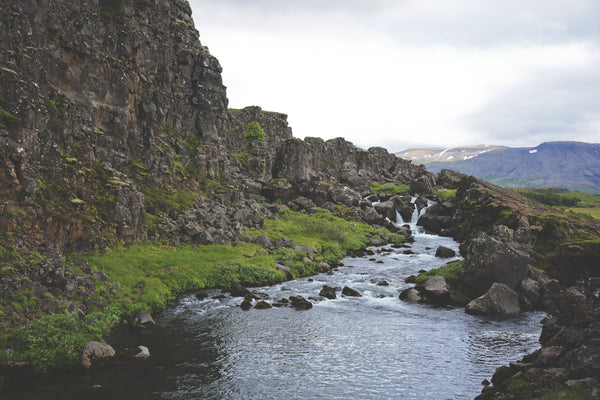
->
[190,0,600,151]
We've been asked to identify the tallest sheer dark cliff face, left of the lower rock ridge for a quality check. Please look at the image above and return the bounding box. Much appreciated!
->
[0,0,234,248]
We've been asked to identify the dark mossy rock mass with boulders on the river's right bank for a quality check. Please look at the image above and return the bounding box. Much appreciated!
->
[420,171,600,400]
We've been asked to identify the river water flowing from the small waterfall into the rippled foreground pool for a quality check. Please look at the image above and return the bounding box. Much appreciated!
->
[0,209,543,400]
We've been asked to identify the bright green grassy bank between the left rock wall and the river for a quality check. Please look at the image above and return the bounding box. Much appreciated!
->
[0,211,402,373]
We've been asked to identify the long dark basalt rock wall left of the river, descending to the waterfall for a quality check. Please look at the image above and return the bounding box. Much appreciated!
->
[0,0,434,334]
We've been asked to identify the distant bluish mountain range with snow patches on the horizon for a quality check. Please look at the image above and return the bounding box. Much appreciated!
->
[396,142,600,193]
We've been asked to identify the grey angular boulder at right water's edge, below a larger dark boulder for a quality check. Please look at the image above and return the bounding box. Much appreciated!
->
[465,282,520,315]
